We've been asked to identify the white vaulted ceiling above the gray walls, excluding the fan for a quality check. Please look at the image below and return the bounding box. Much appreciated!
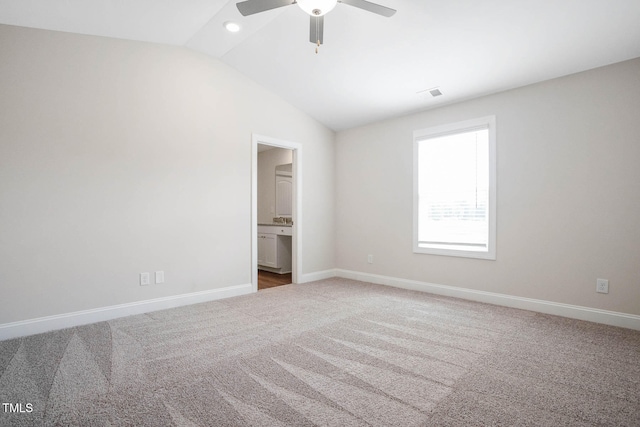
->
[0,0,640,130]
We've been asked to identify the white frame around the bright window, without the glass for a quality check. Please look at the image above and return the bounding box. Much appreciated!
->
[413,116,497,260]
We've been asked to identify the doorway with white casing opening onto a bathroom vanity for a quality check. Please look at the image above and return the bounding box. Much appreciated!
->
[251,134,302,292]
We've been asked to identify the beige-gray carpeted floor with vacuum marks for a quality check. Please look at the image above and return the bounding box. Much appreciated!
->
[0,279,640,427]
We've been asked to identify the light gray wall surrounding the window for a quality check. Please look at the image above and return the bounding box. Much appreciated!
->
[336,59,640,315]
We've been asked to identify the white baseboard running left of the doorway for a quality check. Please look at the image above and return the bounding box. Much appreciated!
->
[0,283,252,341]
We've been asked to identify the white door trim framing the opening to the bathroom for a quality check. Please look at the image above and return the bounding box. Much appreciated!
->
[251,133,304,292]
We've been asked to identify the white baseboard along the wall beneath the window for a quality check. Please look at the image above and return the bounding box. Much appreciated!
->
[335,269,640,330]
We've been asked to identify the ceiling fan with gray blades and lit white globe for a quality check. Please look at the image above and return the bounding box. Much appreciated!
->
[236,0,396,53]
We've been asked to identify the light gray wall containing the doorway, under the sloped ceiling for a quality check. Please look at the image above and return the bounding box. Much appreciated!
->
[0,26,335,324]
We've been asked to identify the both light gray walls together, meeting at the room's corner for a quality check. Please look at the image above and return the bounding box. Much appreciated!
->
[0,21,640,324]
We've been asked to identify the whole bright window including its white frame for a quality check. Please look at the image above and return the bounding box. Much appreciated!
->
[413,116,496,260]
